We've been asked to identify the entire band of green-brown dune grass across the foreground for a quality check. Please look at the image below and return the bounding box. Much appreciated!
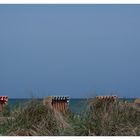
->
[0,99,140,136]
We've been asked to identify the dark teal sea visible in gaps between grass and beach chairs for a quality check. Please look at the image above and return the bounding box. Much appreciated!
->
[8,98,136,113]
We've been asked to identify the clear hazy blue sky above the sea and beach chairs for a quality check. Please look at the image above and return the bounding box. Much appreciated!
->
[0,5,140,98]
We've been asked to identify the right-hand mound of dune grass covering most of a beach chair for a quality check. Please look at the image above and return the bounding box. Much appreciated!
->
[70,99,140,136]
